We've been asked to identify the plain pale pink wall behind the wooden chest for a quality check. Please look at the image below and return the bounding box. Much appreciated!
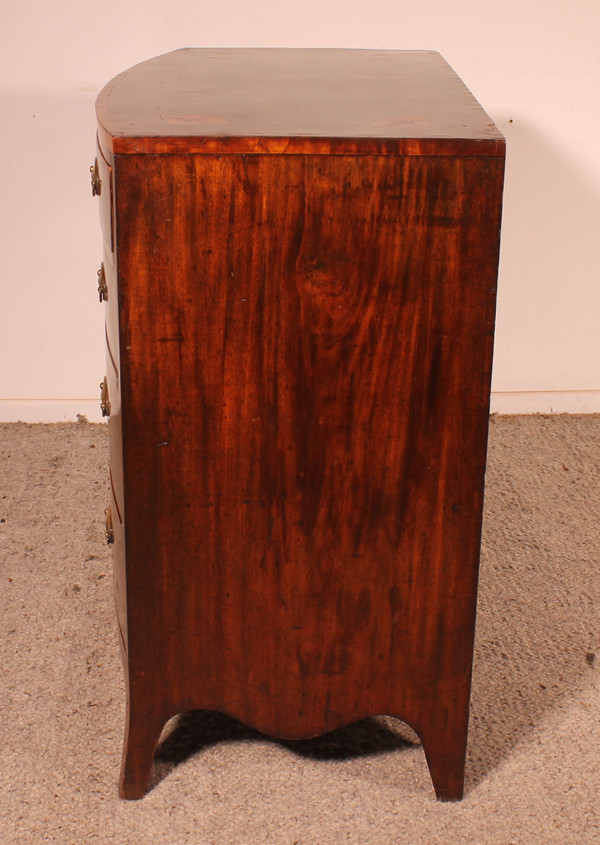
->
[0,0,600,421]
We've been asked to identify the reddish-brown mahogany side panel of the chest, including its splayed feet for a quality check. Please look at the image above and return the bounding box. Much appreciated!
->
[95,51,503,799]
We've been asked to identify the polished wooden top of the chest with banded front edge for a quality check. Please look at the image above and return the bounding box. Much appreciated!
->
[96,48,504,156]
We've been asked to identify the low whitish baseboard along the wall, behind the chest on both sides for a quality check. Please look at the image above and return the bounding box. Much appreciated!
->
[0,390,600,423]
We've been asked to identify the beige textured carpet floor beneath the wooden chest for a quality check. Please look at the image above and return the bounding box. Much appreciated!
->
[0,416,600,845]
